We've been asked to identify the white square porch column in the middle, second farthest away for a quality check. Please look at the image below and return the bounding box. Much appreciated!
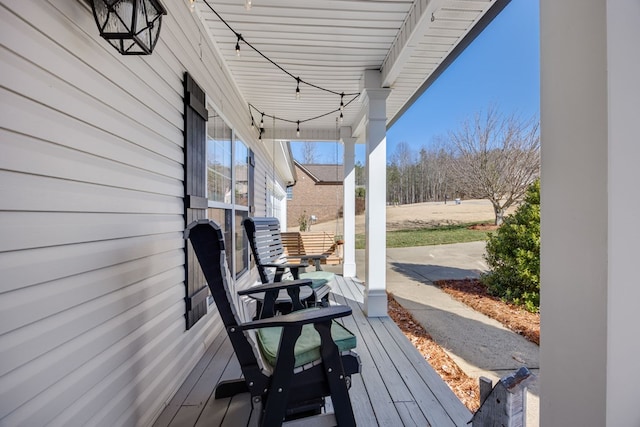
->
[361,70,391,317]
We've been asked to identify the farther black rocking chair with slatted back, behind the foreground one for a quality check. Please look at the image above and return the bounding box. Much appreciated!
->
[242,217,335,312]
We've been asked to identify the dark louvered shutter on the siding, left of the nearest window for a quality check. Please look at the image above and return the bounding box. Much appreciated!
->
[184,73,209,329]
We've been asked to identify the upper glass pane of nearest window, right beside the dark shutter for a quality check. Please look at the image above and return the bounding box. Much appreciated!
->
[207,115,232,203]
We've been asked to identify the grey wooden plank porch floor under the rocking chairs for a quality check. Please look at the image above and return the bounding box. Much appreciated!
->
[155,276,471,427]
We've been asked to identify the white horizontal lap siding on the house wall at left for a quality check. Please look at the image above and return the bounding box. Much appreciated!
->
[0,0,269,426]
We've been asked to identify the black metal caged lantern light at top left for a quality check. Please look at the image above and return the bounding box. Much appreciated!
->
[91,0,167,55]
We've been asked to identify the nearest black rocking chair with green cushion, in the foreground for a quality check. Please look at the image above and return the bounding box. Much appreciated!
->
[185,219,360,426]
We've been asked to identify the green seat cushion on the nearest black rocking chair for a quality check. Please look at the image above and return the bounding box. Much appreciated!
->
[257,321,356,368]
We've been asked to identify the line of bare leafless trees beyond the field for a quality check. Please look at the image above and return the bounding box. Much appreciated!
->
[356,108,540,224]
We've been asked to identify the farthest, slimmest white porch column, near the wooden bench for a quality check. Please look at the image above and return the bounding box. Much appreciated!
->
[340,127,356,277]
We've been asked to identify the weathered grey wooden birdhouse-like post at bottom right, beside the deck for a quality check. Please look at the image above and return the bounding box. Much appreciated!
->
[471,367,535,427]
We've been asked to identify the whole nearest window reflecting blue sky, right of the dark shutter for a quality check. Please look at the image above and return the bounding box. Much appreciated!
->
[206,112,252,277]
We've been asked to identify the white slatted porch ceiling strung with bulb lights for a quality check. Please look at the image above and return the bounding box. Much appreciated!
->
[197,0,508,139]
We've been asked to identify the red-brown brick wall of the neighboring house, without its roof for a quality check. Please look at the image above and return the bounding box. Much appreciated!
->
[287,165,343,231]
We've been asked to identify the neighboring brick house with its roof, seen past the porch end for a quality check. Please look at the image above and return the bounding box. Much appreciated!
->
[287,161,344,230]
